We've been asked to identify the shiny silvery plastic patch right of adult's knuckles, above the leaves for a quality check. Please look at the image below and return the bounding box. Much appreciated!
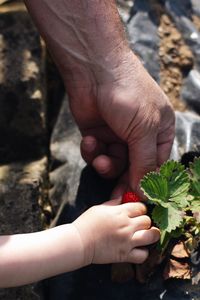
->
[170,111,200,160]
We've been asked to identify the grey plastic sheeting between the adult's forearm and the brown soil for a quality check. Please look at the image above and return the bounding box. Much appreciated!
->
[127,0,160,82]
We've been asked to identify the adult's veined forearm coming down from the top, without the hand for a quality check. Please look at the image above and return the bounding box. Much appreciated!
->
[25,0,133,87]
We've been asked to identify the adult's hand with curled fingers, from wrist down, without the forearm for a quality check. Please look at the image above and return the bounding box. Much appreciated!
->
[70,53,175,192]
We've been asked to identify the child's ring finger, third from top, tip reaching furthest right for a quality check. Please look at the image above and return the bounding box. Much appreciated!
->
[132,227,160,248]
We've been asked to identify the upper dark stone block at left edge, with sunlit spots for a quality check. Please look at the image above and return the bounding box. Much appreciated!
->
[0,6,46,163]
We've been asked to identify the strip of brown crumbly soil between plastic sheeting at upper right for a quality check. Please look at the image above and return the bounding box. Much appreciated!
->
[158,14,193,111]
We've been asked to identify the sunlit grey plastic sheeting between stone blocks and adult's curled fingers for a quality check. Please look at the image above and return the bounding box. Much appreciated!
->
[49,96,85,223]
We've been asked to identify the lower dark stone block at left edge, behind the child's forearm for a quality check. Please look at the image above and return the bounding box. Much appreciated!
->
[0,158,47,300]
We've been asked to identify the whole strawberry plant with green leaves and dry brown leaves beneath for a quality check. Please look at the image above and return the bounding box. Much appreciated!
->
[136,158,200,284]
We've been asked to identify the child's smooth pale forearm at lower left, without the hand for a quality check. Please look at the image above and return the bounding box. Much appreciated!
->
[0,224,84,287]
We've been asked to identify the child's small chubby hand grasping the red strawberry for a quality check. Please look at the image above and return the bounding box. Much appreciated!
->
[72,200,160,265]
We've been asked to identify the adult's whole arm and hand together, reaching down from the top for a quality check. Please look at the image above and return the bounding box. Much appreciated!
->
[25,0,174,195]
